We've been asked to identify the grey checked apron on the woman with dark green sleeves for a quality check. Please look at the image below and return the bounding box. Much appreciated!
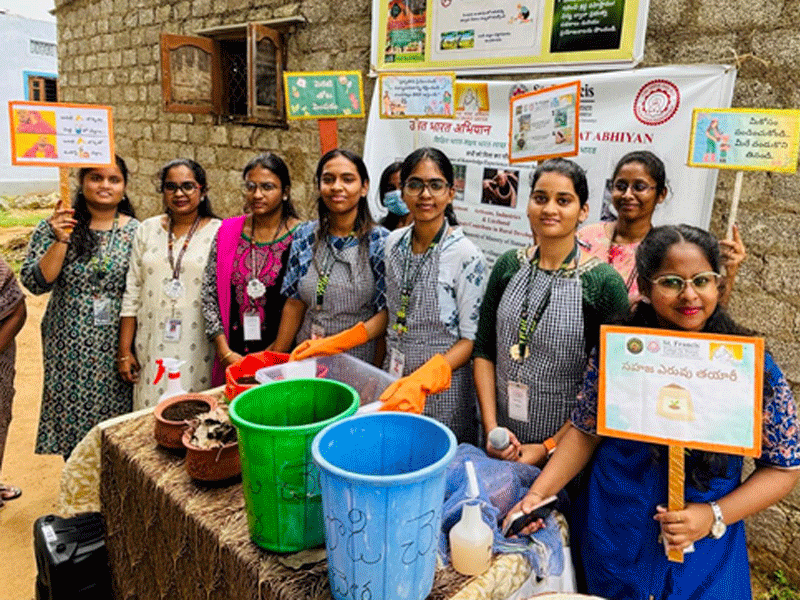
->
[495,247,588,444]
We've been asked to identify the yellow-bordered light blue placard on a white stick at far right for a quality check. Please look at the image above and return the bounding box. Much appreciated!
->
[688,108,800,173]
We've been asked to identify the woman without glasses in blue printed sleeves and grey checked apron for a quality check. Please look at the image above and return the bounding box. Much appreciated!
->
[269,148,388,363]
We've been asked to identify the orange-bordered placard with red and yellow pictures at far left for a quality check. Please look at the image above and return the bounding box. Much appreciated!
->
[8,100,114,167]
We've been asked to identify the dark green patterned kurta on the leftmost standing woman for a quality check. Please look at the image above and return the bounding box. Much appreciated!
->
[20,219,139,456]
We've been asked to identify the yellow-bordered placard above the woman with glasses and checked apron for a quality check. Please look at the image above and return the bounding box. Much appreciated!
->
[379,73,456,119]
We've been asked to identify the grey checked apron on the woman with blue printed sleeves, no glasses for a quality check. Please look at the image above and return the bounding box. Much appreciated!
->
[295,237,375,364]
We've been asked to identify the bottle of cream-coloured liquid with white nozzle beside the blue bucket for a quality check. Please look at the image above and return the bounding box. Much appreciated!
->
[450,460,494,575]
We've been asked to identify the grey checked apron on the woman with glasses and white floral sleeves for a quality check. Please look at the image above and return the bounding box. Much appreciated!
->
[383,230,478,444]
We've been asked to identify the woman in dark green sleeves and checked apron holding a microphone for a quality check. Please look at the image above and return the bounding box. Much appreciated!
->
[473,159,628,464]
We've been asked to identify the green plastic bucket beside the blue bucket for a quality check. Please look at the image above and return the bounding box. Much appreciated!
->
[230,379,359,552]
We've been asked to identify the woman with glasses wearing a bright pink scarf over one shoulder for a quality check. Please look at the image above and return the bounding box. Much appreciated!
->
[203,153,300,386]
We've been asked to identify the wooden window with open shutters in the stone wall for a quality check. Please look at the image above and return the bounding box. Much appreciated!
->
[161,17,305,127]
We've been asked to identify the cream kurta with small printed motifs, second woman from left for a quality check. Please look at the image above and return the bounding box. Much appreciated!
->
[121,215,220,410]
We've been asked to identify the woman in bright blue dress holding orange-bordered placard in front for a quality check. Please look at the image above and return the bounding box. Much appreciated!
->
[511,225,800,600]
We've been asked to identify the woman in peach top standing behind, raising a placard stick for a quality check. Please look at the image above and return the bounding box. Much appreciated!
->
[578,150,745,305]
